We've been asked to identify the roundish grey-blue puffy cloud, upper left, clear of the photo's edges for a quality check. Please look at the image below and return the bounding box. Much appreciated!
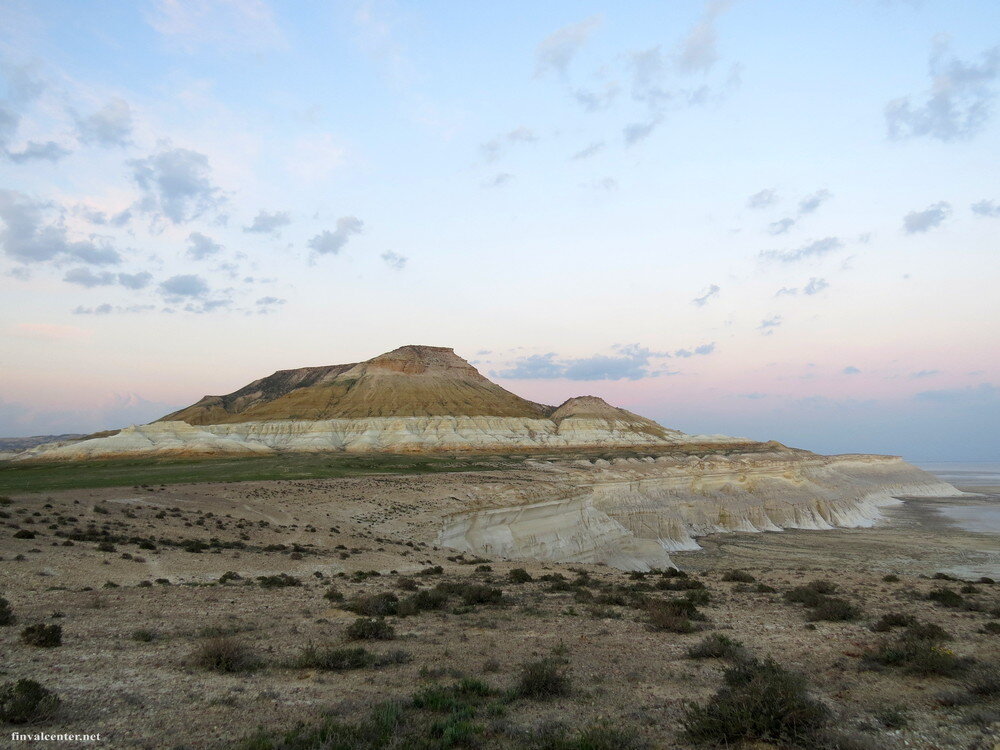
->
[128,148,223,224]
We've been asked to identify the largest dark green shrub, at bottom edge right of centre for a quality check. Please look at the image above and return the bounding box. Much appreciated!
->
[681,659,828,744]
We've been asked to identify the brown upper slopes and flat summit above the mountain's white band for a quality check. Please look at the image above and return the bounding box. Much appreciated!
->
[159,345,560,425]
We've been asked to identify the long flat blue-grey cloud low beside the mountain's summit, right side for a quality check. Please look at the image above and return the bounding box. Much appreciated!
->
[490,344,672,381]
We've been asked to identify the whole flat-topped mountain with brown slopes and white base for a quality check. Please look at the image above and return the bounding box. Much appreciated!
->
[17,345,728,459]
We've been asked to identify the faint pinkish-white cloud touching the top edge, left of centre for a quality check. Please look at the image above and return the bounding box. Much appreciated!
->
[147,0,288,52]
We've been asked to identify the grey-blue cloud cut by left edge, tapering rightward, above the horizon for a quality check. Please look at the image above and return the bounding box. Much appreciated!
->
[0,189,121,265]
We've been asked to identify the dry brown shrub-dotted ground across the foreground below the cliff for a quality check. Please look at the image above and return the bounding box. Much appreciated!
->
[0,472,1000,750]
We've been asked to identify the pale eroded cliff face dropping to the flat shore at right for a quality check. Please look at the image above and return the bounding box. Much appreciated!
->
[438,450,961,570]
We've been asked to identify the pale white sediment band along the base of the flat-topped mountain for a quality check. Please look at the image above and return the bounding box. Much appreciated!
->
[16,417,751,460]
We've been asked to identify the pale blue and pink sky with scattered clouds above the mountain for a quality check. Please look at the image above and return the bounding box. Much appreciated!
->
[0,0,1000,460]
